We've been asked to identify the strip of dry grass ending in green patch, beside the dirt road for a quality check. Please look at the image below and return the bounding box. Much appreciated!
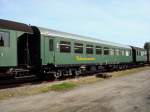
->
[0,82,78,100]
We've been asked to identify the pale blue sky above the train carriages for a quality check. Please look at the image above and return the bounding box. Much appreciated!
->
[0,0,150,47]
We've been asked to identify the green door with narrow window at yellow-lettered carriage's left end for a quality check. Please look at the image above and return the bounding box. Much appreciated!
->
[44,36,55,64]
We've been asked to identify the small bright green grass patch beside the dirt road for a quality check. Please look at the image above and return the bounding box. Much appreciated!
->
[50,82,78,91]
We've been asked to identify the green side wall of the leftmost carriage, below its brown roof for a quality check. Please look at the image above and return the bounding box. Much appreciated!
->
[0,28,18,67]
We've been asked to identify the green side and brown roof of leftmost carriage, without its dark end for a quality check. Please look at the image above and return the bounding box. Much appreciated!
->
[0,19,33,75]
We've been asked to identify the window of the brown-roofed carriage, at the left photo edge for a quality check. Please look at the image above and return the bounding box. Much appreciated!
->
[0,31,10,47]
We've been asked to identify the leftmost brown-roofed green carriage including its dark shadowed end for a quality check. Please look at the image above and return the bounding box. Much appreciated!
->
[0,19,40,77]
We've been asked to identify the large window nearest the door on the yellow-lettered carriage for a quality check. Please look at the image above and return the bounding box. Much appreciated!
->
[60,41,71,53]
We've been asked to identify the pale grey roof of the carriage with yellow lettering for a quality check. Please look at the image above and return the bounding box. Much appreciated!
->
[38,27,131,49]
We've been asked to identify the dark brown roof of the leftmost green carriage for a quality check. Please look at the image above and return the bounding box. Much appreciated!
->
[0,19,33,33]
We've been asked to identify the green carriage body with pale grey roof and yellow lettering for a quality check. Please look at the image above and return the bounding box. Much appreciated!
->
[39,28,132,66]
